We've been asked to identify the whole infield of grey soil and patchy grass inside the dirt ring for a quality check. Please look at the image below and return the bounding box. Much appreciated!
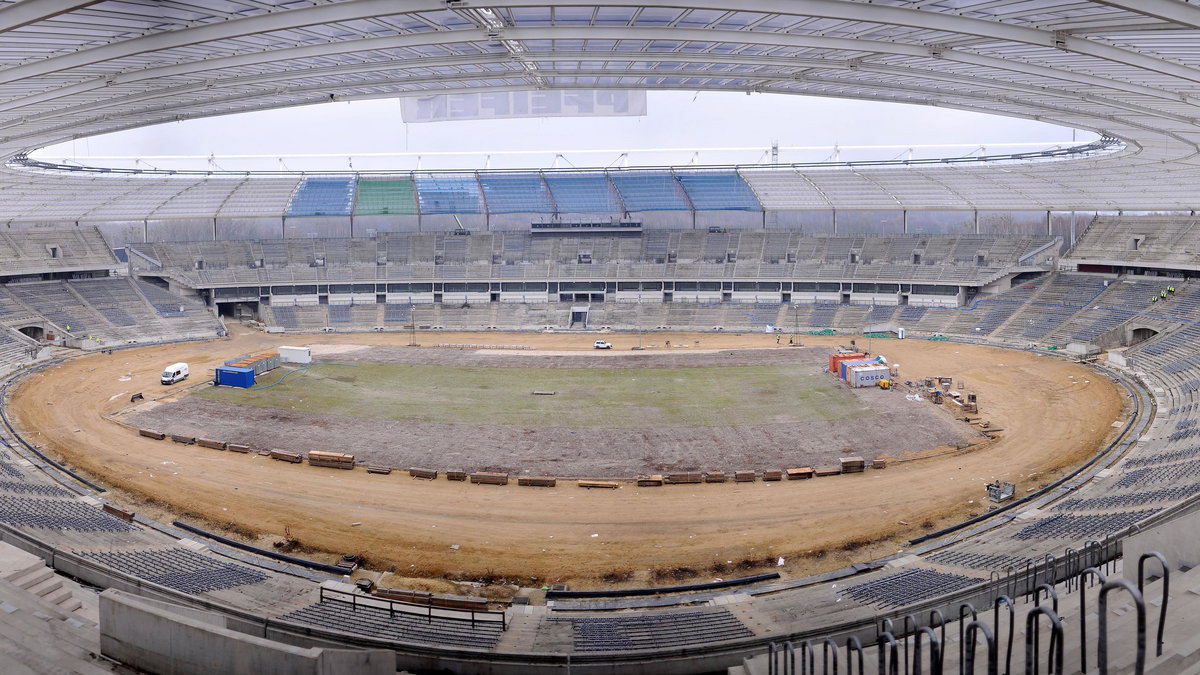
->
[118,347,983,478]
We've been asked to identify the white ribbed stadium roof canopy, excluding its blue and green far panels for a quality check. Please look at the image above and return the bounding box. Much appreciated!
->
[0,0,1200,222]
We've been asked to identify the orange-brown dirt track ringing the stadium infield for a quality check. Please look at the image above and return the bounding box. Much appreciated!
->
[11,330,1126,583]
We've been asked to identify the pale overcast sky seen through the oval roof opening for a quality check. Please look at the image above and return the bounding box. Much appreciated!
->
[36,91,1096,171]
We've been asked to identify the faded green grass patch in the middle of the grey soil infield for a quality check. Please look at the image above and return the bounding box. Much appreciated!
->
[193,363,862,428]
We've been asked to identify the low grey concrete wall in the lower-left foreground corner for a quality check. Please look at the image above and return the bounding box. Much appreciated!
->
[100,590,396,675]
